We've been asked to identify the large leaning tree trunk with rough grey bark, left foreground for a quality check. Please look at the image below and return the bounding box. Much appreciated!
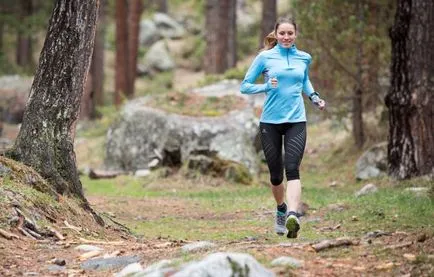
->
[7,0,103,224]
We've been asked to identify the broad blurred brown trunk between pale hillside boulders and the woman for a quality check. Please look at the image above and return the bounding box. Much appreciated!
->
[204,0,230,74]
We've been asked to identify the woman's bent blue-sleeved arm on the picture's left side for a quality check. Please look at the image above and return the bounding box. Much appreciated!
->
[240,55,271,94]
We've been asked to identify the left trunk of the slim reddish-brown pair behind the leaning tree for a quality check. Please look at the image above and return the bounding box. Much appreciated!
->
[114,0,130,106]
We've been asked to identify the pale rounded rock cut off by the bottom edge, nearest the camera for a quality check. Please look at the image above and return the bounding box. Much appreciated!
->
[172,252,275,277]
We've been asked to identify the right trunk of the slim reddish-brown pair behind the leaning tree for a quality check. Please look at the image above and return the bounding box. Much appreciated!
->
[127,0,143,98]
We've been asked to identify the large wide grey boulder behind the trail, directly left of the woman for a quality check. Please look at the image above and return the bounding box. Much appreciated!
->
[105,98,259,175]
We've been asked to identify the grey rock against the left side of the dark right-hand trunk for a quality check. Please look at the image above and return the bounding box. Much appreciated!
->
[356,142,387,180]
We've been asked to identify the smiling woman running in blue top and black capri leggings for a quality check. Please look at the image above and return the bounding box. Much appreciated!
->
[240,18,325,238]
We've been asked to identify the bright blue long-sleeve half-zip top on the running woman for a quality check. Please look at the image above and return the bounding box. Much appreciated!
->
[240,44,314,124]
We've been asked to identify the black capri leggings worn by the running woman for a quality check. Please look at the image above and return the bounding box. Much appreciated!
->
[259,122,306,186]
